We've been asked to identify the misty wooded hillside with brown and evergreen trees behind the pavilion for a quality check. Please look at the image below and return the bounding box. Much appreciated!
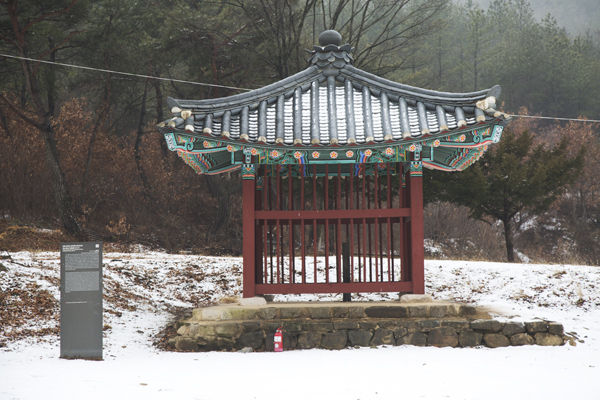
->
[0,0,600,265]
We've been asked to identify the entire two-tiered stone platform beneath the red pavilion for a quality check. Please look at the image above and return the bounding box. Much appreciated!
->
[169,299,565,351]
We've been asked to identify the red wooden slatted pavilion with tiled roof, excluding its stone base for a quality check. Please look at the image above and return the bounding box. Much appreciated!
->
[159,31,508,297]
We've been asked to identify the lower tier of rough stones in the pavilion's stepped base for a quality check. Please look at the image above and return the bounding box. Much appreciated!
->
[170,318,565,351]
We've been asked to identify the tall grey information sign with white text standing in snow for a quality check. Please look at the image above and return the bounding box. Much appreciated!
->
[60,242,102,360]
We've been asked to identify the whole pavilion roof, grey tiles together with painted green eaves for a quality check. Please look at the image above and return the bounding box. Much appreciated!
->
[159,31,509,174]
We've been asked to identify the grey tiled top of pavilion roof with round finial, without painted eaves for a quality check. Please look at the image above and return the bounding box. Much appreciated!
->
[159,33,507,174]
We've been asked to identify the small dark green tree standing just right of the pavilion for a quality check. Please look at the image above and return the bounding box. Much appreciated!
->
[430,129,583,262]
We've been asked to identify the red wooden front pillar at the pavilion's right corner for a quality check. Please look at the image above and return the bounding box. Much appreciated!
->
[408,161,425,294]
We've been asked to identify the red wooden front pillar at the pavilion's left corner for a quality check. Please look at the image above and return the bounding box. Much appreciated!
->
[242,164,256,297]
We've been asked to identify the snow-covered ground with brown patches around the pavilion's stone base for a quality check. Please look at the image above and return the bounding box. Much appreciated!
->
[0,251,600,400]
